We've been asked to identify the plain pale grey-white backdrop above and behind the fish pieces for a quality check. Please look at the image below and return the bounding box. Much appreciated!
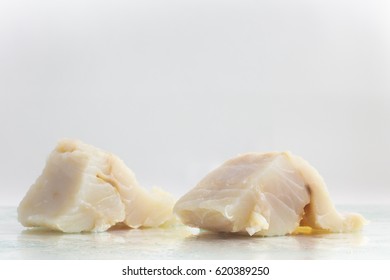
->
[0,0,390,205]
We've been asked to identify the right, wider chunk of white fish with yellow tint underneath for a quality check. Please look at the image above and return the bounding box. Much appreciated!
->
[174,152,365,236]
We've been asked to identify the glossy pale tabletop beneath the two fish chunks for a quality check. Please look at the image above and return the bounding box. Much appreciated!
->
[0,205,390,260]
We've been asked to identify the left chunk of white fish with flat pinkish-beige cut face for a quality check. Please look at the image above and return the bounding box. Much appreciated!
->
[18,139,174,232]
